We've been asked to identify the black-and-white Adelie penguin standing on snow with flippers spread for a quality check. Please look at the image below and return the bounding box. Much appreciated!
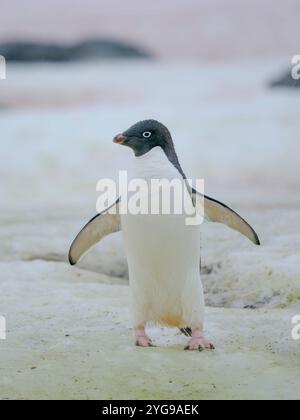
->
[69,120,259,350]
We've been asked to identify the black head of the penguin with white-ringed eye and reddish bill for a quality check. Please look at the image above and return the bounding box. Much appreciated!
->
[114,120,174,156]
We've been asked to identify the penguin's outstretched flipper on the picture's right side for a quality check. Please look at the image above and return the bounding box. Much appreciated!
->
[192,188,260,245]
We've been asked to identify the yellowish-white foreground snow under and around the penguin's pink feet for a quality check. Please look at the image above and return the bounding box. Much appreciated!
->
[0,261,300,399]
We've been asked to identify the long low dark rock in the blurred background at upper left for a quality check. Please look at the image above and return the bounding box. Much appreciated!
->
[0,39,152,62]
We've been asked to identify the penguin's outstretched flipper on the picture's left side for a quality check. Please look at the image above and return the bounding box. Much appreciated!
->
[69,199,121,265]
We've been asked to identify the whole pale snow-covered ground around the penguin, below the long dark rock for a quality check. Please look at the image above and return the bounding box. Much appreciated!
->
[0,61,300,398]
